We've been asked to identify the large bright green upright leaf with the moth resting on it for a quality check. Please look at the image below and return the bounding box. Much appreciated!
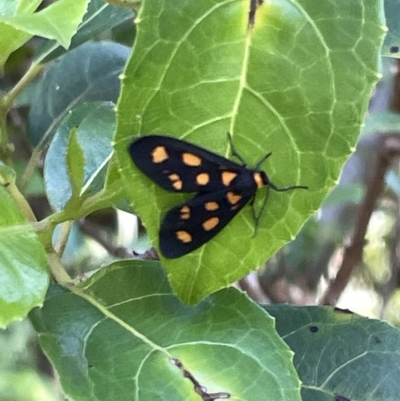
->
[115,0,383,303]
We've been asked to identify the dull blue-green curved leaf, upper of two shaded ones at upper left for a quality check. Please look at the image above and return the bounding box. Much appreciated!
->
[28,42,128,146]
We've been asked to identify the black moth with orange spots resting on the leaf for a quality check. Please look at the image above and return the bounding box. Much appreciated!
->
[129,135,307,258]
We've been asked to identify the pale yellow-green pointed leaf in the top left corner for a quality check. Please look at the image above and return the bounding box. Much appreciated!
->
[0,0,89,48]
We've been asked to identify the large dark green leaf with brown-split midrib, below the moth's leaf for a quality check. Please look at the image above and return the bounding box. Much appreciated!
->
[31,261,300,401]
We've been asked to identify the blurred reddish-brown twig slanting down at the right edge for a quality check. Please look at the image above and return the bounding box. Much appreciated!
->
[321,133,400,306]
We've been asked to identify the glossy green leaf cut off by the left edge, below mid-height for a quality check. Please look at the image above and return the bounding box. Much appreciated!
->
[0,186,49,327]
